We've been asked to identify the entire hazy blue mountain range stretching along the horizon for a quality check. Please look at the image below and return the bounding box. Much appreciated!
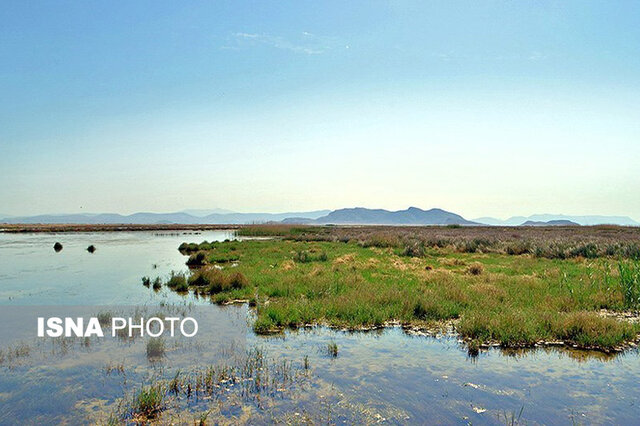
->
[0,207,640,226]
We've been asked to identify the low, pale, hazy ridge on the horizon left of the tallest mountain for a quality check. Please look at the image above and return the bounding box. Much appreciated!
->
[3,210,330,225]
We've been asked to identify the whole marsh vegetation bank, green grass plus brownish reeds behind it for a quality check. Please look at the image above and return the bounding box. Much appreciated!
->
[149,225,640,352]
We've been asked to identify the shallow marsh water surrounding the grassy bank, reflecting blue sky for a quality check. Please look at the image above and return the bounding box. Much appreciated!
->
[0,232,640,424]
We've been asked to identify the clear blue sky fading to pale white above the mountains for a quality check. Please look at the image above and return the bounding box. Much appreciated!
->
[0,0,640,219]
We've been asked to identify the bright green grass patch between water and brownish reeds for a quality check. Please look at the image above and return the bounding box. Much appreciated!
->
[172,239,640,348]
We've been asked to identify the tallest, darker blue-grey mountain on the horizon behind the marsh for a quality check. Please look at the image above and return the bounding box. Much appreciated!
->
[314,207,476,225]
